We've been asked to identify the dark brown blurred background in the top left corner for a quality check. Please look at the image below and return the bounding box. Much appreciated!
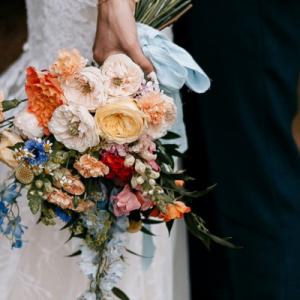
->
[0,0,26,73]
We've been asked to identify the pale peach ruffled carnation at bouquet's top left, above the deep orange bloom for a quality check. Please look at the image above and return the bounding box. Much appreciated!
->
[50,49,87,80]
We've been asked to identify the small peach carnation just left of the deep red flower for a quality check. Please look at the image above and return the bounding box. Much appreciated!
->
[74,154,109,178]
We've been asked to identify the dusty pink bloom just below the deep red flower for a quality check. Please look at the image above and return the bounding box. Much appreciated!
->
[112,184,141,217]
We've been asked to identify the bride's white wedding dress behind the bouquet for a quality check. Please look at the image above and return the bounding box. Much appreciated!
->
[0,0,189,300]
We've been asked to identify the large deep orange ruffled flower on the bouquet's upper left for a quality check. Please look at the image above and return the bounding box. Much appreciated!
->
[25,67,64,135]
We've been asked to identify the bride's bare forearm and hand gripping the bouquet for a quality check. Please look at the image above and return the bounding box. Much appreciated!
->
[93,0,153,74]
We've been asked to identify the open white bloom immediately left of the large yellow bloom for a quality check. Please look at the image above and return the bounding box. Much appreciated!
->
[49,105,99,152]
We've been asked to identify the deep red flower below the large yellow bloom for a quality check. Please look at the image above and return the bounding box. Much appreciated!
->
[101,152,134,184]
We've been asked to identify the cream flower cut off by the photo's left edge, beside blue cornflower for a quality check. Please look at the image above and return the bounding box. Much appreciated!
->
[0,130,23,169]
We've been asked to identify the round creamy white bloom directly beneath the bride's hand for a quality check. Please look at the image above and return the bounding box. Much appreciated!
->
[101,54,144,97]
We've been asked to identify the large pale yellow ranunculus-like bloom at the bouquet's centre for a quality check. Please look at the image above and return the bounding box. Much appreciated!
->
[95,98,146,144]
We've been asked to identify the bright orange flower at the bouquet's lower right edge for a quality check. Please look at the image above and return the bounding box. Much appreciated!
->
[151,201,191,222]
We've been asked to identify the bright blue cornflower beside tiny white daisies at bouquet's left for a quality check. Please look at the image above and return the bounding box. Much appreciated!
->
[24,140,49,166]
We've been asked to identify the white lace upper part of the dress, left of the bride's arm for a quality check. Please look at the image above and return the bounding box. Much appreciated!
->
[25,0,97,68]
